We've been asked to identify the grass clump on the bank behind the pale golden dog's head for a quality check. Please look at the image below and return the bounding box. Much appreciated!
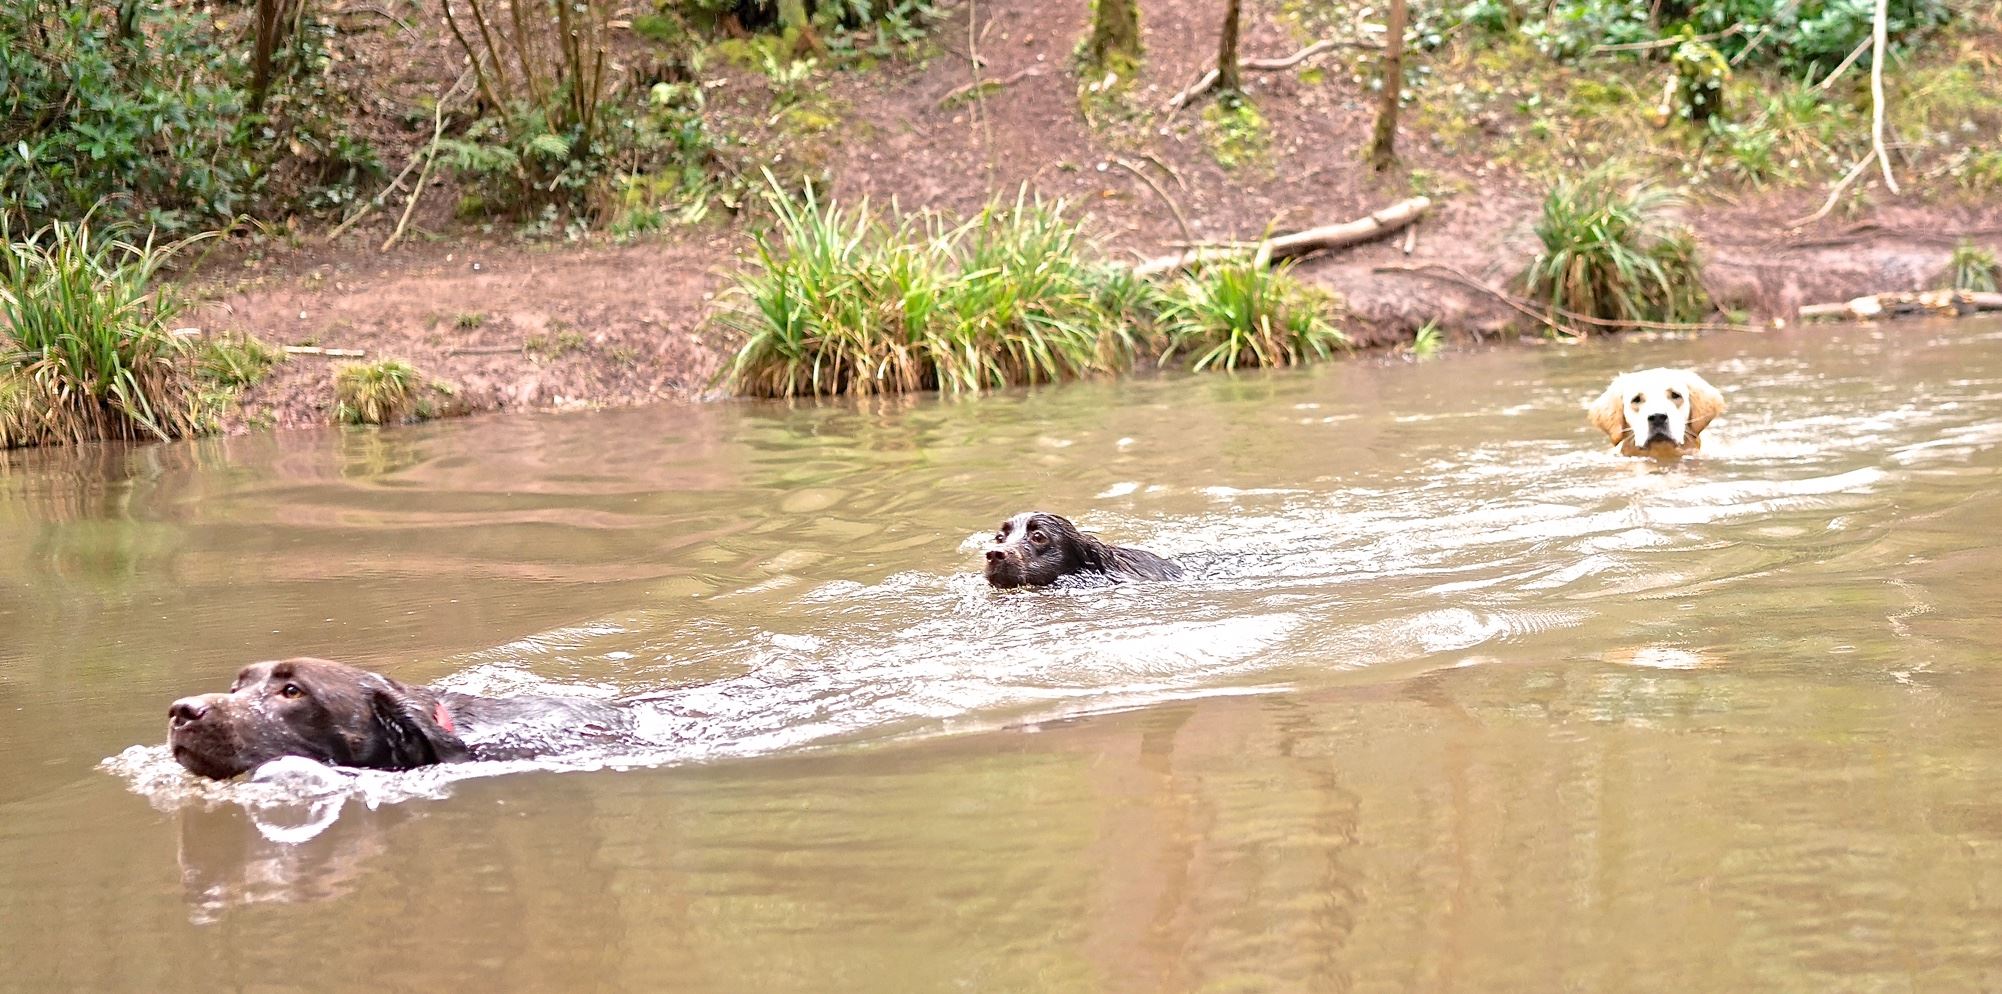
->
[1526,166,1710,330]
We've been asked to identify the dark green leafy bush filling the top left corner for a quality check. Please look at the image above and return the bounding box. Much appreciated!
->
[0,0,380,234]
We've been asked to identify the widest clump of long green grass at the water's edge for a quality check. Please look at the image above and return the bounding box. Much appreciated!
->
[723,180,1145,396]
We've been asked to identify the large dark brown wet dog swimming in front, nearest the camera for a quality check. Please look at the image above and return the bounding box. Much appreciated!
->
[166,658,631,780]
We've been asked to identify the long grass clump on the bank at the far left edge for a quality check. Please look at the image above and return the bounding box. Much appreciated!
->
[0,218,198,448]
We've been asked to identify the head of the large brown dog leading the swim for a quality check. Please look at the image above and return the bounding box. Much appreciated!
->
[166,658,466,780]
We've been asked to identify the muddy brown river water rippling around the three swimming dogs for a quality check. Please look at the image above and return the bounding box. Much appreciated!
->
[0,322,2002,992]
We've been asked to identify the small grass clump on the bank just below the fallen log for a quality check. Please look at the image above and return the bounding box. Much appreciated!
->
[1161,250,1349,372]
